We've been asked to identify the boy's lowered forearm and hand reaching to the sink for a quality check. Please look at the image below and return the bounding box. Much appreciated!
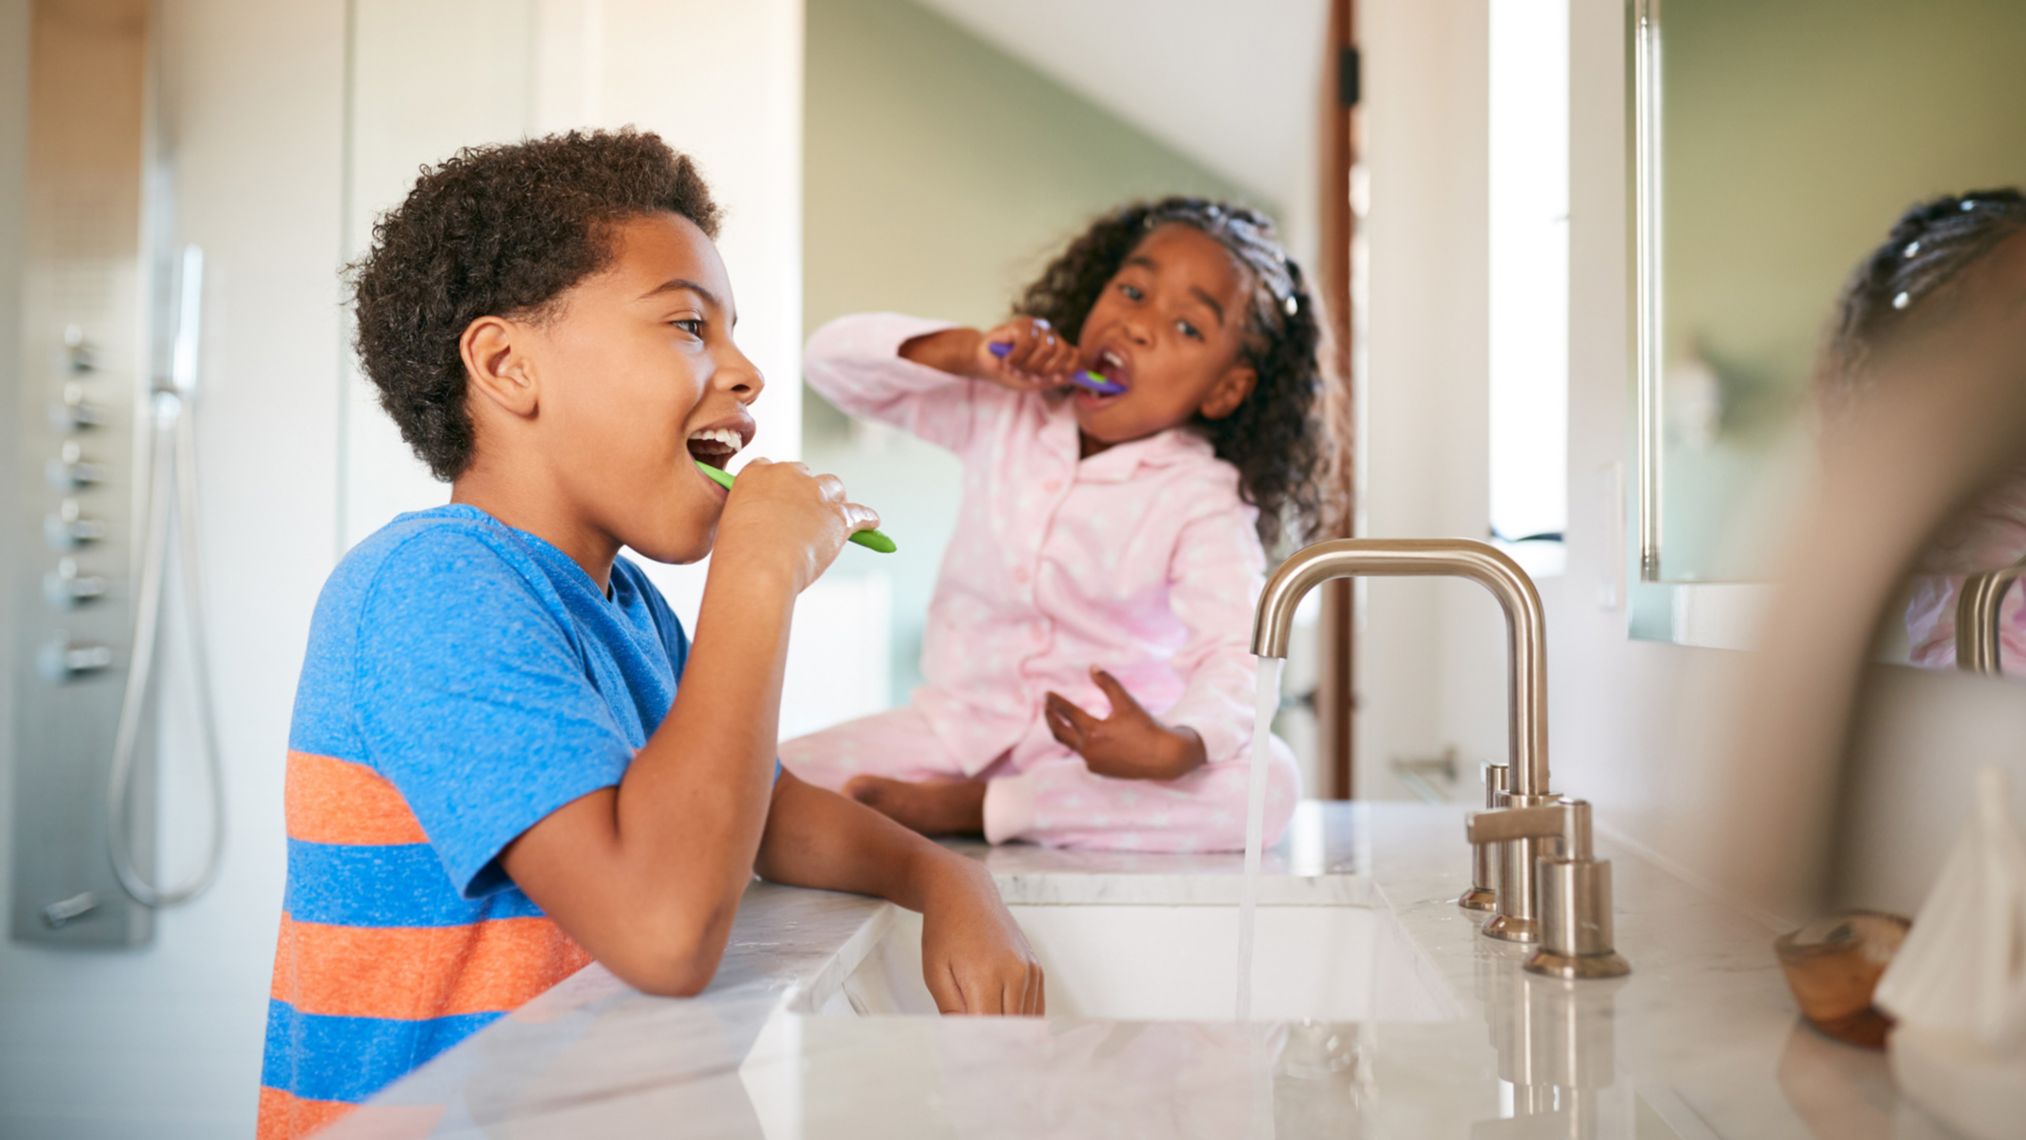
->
[758,771,1045,1014]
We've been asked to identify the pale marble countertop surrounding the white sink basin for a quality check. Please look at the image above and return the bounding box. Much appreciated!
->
[312,804,1945,1140]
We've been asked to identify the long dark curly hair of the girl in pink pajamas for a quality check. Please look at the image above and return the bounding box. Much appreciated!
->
[1013,196,1345,547]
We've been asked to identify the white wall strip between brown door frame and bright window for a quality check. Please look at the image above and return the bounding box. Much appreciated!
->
[1355,0,1515,800]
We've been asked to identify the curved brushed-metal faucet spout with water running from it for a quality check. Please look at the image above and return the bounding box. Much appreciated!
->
[1252,539,1548,806]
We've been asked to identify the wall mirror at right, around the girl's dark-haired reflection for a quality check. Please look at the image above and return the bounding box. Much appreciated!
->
[1627,0,2026,668]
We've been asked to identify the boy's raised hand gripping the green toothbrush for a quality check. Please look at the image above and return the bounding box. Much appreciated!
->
[711,460,879,593]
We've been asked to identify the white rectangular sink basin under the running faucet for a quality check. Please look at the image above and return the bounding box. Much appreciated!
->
[802,903,1457,1021]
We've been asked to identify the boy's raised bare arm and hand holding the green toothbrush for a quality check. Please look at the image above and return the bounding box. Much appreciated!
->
[500,462,877,996]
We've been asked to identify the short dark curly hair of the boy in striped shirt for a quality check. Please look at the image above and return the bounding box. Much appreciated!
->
[346,128,719,480]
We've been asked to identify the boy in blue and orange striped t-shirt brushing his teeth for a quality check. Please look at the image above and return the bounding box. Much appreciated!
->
[259,132,1041,1136]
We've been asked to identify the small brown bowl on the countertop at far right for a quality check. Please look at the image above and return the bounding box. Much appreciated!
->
[1773,911,1913,1049]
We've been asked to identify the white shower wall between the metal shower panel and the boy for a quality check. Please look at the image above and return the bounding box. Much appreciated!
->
[0,0,344,1138]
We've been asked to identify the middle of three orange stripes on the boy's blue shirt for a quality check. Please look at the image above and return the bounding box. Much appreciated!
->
[267,915,592,1021]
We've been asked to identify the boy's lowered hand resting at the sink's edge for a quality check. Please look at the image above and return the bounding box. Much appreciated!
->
[922,848,1047,1016]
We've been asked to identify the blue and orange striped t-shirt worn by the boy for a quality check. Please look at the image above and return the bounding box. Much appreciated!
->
[259,506,689,1140]
